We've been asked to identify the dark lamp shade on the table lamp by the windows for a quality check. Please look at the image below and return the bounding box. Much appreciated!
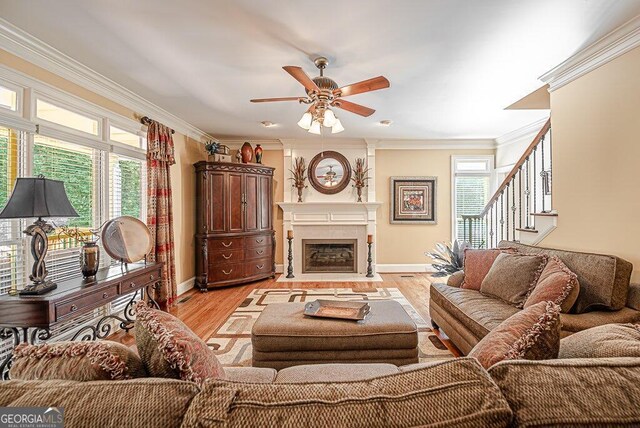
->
[0,176,79,218]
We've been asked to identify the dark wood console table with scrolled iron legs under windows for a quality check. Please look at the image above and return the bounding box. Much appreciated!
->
[0,263,162,379]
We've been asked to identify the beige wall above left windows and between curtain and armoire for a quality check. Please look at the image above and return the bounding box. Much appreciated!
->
[0,49,206,284]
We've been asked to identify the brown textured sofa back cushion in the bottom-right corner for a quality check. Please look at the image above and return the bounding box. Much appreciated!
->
[489,358,640,427]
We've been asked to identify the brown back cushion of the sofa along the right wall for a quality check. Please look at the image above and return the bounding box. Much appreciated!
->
[499,241,633,313]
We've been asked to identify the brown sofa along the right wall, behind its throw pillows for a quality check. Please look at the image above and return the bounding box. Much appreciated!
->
[429,241,640,354]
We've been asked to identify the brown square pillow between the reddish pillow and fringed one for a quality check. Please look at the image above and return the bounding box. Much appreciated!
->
[480,253,547,308]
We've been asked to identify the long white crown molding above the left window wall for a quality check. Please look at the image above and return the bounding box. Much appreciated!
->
[0,18,215,142]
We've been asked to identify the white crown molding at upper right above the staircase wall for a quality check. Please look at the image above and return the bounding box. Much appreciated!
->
[540,15,640,92]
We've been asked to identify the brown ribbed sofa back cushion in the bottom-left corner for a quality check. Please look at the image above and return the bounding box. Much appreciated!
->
[0,378,200,428]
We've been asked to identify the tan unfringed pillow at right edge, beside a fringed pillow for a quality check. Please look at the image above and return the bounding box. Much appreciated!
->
[558,324,640,358]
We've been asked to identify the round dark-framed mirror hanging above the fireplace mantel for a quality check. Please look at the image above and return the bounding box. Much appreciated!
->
[309,151,351,195]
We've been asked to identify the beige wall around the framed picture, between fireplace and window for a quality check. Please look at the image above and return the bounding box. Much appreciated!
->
[375,150,494,265]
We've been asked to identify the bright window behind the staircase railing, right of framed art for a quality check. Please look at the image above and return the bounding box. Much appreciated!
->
[452,156,493,247]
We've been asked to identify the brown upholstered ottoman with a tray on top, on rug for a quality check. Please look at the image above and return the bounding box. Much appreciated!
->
[251,300,418,370]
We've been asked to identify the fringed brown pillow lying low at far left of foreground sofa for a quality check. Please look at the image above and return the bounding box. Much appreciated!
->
[9,341,147,382]
